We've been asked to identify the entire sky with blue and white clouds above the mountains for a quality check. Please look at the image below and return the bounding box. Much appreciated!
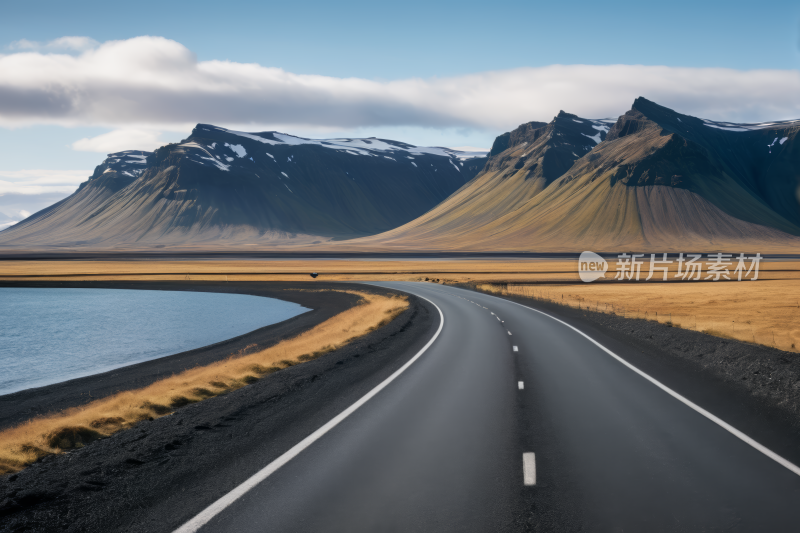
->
[0,0,800,224]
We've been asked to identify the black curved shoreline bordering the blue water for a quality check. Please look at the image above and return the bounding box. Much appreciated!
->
[0,281,364,429]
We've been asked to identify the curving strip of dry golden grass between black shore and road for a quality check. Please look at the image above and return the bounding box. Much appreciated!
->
[0,291,408,474]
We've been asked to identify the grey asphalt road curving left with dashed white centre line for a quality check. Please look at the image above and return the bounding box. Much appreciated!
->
[179,282,800,532]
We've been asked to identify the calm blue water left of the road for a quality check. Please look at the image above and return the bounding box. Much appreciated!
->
[0,288,308,394]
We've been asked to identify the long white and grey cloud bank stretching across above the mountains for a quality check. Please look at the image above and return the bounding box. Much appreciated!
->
[0,37,800,134]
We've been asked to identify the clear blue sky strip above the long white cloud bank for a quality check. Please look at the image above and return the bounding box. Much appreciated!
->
[6,0,800,79]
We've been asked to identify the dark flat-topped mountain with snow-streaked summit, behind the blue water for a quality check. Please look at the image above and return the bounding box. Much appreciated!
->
[0,124,486,248]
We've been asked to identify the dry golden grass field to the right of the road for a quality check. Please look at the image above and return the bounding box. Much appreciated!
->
[478,280,800,352]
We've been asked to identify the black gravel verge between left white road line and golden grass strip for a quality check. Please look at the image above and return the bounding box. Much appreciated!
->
[0,283,439,533]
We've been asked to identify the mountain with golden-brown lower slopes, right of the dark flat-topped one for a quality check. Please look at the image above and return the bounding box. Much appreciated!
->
[350,98,800,252]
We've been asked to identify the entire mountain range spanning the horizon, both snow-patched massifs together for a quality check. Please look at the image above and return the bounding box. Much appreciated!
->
[0,97,800,252]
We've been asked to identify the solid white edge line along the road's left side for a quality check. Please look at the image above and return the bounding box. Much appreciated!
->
[174,295,444,533]
